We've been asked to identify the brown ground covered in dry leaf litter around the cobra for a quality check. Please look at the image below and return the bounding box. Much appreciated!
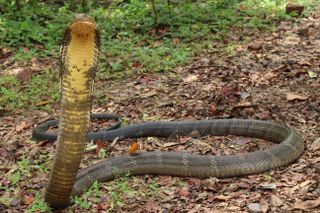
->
[0,6,320,212]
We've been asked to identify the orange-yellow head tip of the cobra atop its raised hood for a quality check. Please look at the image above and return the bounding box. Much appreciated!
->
[69,14,96,35]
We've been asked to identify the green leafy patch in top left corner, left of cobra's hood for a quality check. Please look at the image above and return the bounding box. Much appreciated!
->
[0,1,70,60]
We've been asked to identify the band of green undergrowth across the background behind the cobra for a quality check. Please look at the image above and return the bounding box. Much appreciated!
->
[0,0,318,113]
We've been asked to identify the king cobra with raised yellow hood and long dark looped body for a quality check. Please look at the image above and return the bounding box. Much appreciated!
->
[33,14,304,208]
